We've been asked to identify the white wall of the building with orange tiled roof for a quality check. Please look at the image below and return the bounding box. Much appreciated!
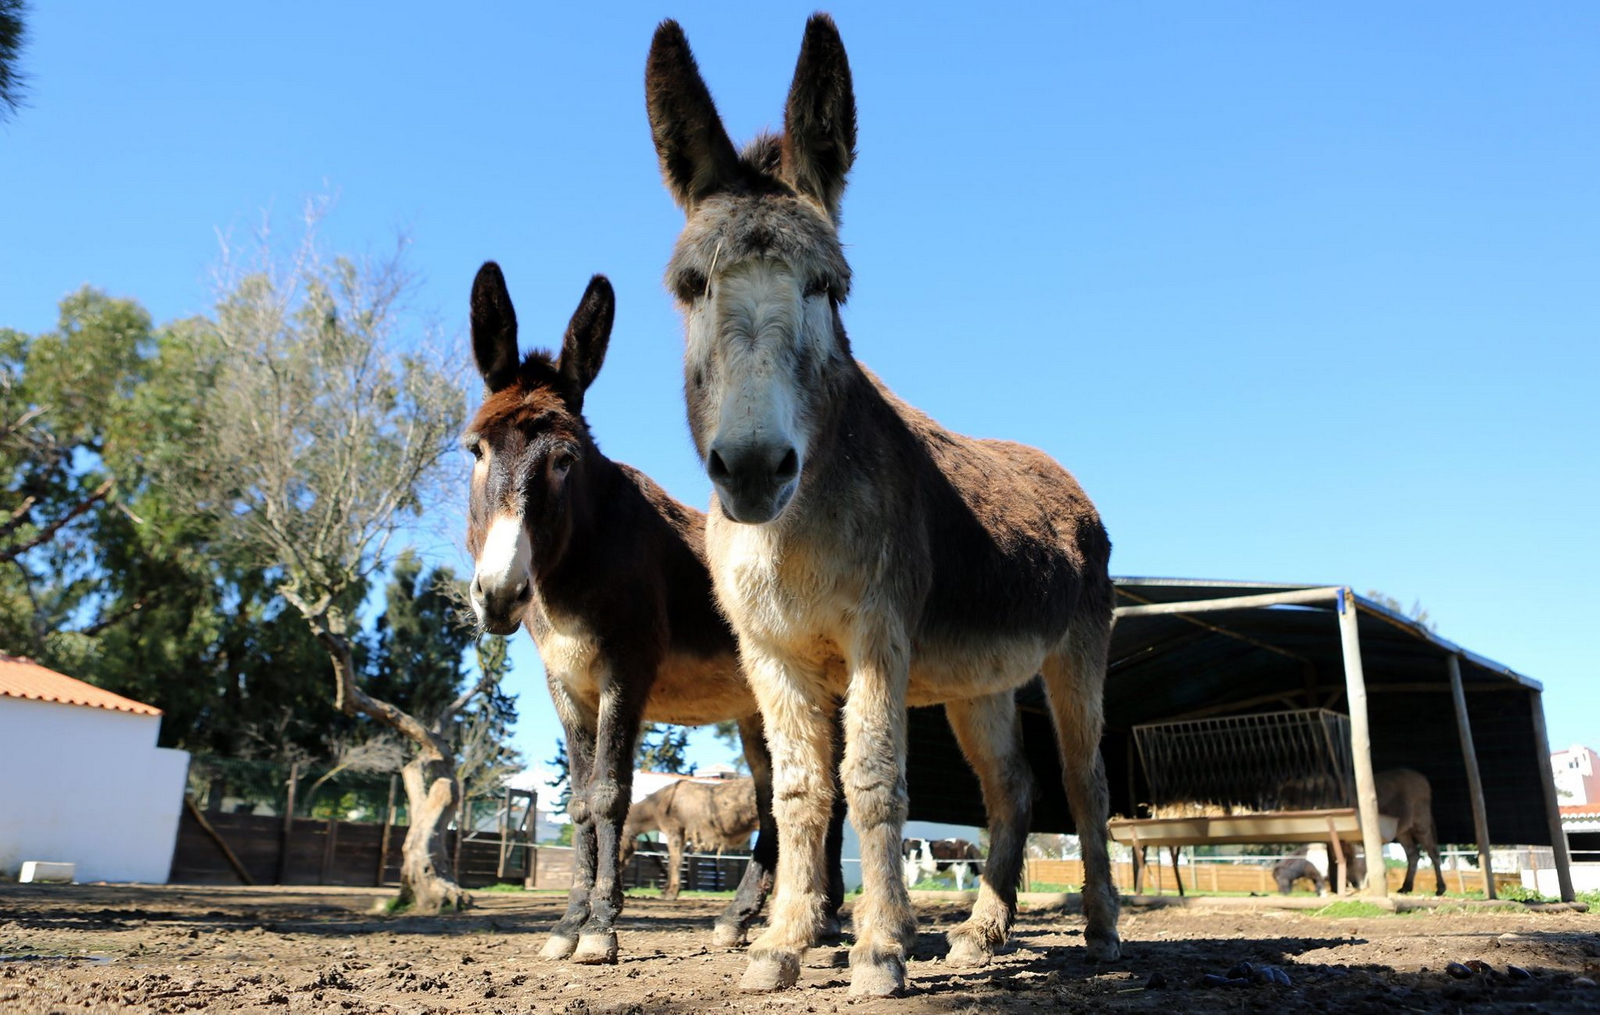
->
[0,698,189,884]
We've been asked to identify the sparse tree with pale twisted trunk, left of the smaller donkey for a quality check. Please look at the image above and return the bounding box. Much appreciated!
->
[184,205,476,913]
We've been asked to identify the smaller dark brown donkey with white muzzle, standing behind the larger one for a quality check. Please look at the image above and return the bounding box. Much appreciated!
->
[464,261,843,962]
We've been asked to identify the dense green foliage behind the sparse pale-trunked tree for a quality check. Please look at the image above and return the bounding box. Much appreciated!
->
[0,268,515,774]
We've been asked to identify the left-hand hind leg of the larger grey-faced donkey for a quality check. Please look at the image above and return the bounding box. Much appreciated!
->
[944,692,1034,965]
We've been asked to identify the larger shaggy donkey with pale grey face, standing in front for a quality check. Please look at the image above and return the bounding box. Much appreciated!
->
[645,14,1120,994]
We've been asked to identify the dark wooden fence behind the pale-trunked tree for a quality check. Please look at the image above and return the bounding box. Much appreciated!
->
[170,808,531,889]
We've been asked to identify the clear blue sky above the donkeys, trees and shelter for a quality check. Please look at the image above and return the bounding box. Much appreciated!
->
[0,0,1600,774]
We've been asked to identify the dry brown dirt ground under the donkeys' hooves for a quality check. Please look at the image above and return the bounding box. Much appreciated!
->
[0,885,1600,1015]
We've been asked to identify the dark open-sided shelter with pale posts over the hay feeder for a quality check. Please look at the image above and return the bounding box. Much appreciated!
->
[907,578,1573,901]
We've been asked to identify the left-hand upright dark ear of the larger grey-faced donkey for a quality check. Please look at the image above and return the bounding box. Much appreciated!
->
[645,18,739,211]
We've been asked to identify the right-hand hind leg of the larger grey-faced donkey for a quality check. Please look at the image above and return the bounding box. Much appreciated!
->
[1043,621,1122,962]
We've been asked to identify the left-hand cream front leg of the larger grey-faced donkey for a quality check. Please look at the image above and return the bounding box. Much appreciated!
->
[739,645,834,991]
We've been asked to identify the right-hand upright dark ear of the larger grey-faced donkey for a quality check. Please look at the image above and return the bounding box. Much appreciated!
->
[784,14,856,223]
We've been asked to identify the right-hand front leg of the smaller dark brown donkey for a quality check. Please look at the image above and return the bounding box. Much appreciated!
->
[573,668,654,965]
